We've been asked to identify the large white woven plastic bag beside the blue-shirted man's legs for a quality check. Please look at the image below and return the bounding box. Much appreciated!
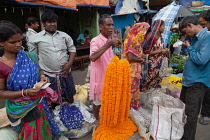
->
[150,97,186,140]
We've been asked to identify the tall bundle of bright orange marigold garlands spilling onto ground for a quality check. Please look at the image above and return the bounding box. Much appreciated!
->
[93,56,137,140]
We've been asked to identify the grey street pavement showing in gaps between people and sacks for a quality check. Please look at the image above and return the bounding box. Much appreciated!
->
[0,65,210,140]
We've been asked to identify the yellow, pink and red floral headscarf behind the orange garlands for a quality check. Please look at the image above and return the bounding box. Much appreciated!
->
[123,22,150,56]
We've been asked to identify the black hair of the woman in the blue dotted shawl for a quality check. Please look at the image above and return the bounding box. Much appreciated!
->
[0,21,22,42]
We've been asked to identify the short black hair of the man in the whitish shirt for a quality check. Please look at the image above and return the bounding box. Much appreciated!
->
[41,9,58,23]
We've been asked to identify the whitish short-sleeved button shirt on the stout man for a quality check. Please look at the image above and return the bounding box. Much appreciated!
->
[27,30,76,77]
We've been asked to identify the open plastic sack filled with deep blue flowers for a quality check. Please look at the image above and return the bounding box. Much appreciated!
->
[53,101,95,138]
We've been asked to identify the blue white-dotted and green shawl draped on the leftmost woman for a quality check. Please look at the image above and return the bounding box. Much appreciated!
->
[6,50,41,126]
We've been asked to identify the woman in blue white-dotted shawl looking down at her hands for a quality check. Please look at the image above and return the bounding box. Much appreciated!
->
[0,21,62,140]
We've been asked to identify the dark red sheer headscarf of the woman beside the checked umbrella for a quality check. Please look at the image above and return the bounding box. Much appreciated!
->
[144,19,164,54]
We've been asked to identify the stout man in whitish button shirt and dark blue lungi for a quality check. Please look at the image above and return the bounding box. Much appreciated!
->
[28,10,76,104]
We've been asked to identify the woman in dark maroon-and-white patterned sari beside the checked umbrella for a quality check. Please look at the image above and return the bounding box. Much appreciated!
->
[142,20,169,90]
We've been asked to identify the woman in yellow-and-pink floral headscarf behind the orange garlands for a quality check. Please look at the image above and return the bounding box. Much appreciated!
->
[122,23,150,109]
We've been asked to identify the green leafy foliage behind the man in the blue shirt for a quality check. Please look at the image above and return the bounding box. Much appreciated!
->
[170,54,187,74]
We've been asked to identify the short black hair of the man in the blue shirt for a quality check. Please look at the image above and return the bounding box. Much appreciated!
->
[179,16,199,30]
